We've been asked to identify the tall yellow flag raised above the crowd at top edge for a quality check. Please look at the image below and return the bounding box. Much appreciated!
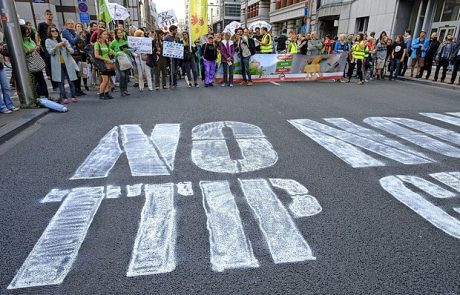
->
[189,0,208,42]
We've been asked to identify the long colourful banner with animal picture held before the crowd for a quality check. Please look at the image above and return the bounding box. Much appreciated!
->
[215,53,347,82]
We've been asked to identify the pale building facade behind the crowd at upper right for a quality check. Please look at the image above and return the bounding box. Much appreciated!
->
[241,0,460,39]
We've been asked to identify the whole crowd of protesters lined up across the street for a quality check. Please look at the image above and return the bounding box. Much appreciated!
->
[0,10,460,113]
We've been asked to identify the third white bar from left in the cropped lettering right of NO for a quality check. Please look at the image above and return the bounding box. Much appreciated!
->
[363,117,460,158]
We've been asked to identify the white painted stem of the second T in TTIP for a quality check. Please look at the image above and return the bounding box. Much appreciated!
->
[126,183,176,277]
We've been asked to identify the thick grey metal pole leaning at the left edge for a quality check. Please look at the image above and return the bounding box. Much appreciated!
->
[0,0,34,105]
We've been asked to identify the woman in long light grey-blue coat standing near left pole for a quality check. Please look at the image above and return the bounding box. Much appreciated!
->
[45,26,78,104]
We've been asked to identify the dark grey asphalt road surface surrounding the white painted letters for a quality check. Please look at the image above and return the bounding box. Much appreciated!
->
[0,81,460,294]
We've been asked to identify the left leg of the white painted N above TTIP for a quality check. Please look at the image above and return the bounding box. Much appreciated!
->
[70,127,123,179]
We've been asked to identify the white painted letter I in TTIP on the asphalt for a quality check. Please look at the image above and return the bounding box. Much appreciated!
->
[200,181,259,272]
